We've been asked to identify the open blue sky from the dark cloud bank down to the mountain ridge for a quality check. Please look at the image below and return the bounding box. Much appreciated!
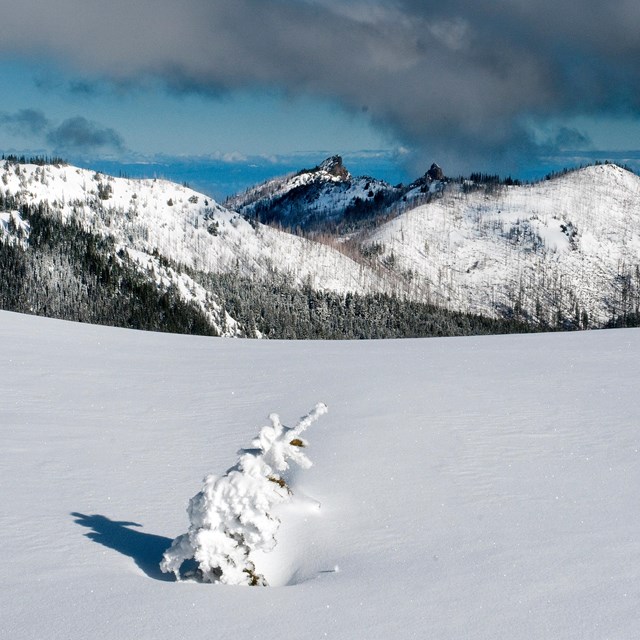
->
[0,58,412,198]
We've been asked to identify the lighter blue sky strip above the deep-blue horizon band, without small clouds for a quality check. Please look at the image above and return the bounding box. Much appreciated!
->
[0,59,397,156]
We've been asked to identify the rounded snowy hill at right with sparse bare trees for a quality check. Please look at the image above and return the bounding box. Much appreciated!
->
[362,165,640,326]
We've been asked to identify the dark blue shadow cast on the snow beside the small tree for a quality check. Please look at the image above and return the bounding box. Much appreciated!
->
[71,511,175,582]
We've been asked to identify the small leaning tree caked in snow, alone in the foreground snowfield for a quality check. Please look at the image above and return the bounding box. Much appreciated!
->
[160,403,327,586]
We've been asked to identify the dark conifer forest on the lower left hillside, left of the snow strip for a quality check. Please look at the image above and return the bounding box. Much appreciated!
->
[0,204,215,335]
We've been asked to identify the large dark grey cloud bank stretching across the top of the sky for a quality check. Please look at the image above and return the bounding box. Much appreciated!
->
[0,0,640,170]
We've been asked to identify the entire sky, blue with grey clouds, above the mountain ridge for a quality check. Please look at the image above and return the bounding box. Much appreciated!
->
[0,0,640,197]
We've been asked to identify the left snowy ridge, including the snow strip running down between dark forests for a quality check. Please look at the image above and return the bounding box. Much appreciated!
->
[0,161,400,335]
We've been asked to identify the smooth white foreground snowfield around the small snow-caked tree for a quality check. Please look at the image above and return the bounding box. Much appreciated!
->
[0,312,640,640]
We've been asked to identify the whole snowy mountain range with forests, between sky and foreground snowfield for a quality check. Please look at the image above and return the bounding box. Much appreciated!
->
[0,156,640,337]
